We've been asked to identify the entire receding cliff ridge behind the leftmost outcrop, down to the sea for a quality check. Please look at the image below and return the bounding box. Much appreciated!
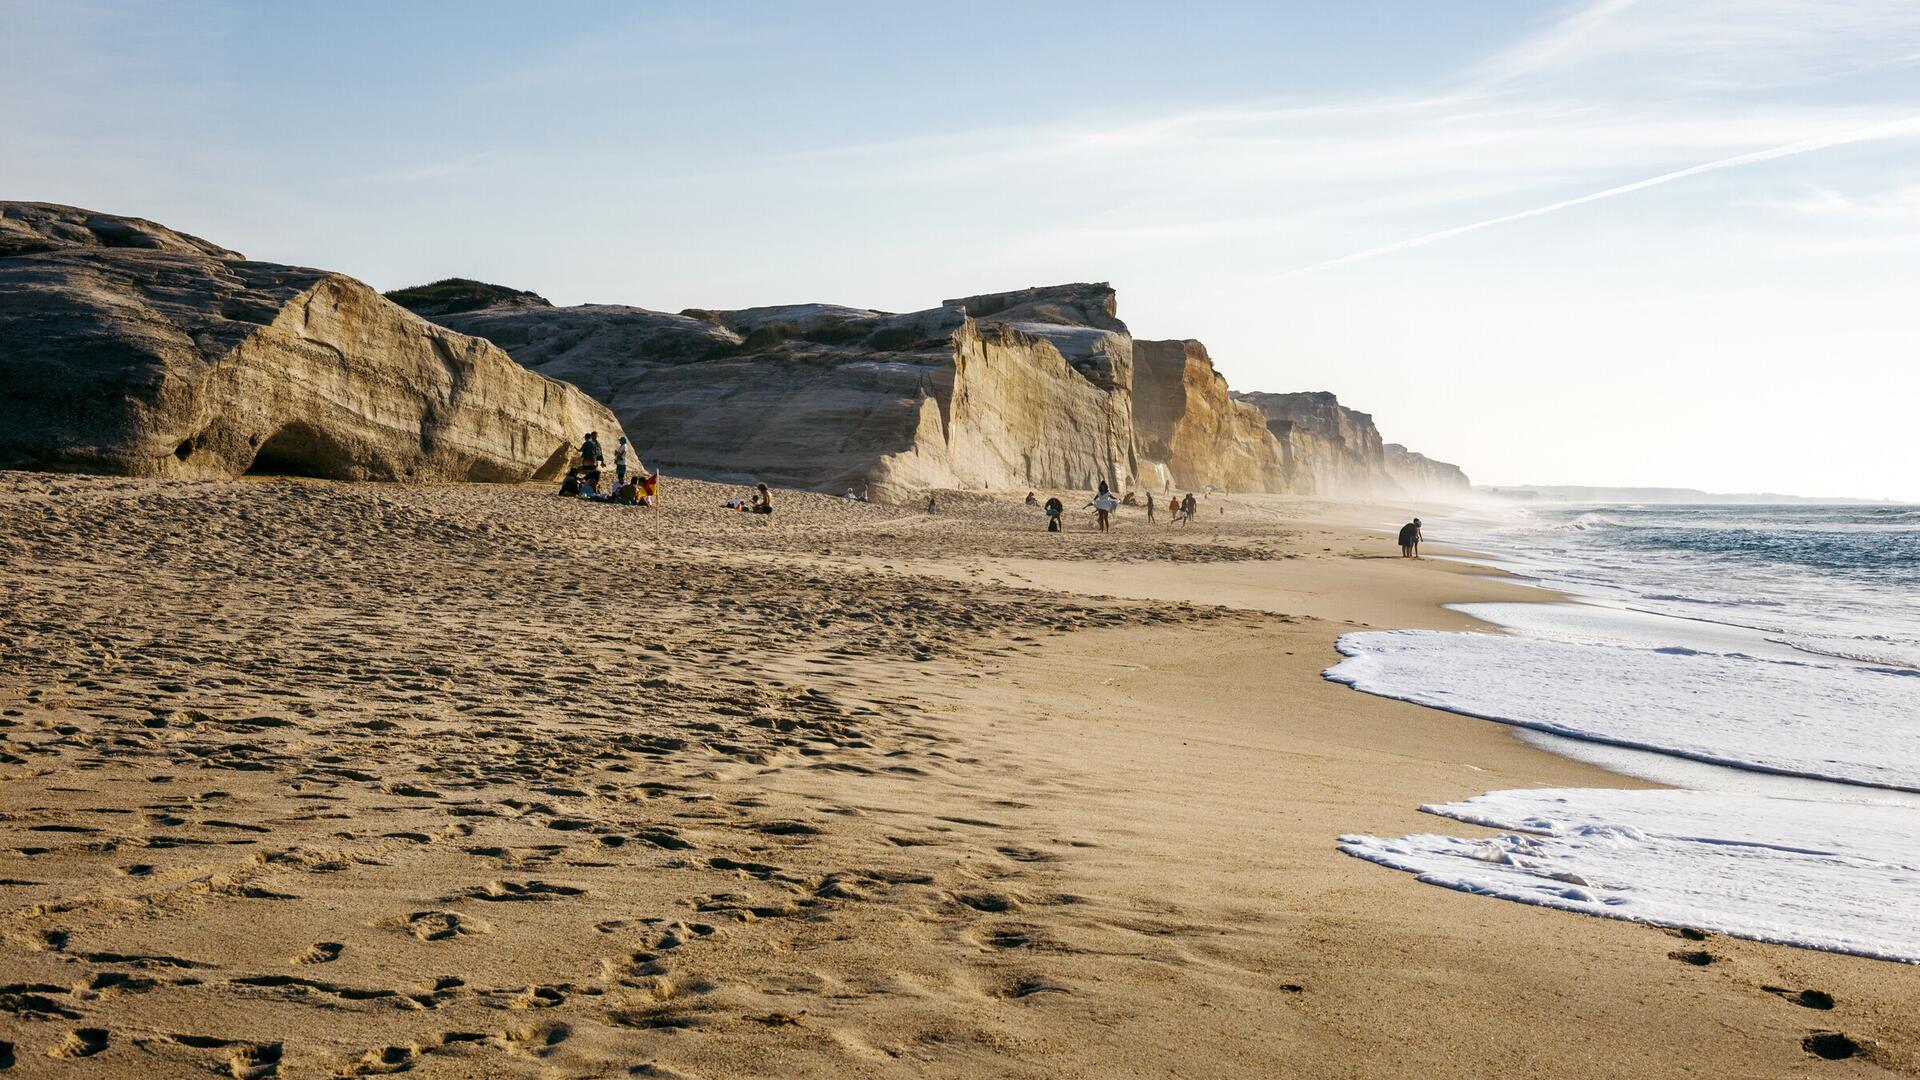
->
[408,282,1467,496]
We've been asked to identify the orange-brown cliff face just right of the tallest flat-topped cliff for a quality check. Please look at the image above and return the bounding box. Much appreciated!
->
[1133,340,1294,492]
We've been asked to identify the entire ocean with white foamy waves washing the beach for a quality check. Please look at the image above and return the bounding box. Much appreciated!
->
[1327,503,1920,963]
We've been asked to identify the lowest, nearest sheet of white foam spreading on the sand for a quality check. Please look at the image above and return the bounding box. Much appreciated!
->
[1340,788,1920,963]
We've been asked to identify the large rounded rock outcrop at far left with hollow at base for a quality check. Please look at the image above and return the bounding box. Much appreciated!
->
[0,202,618,480]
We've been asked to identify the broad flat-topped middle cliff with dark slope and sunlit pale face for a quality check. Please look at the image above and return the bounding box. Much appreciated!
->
[420,284,1135,492]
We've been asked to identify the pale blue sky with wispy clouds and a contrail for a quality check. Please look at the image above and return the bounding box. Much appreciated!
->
[0,0,1920,500]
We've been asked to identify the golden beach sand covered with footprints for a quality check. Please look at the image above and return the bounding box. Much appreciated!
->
[0,473,1920,1078]
